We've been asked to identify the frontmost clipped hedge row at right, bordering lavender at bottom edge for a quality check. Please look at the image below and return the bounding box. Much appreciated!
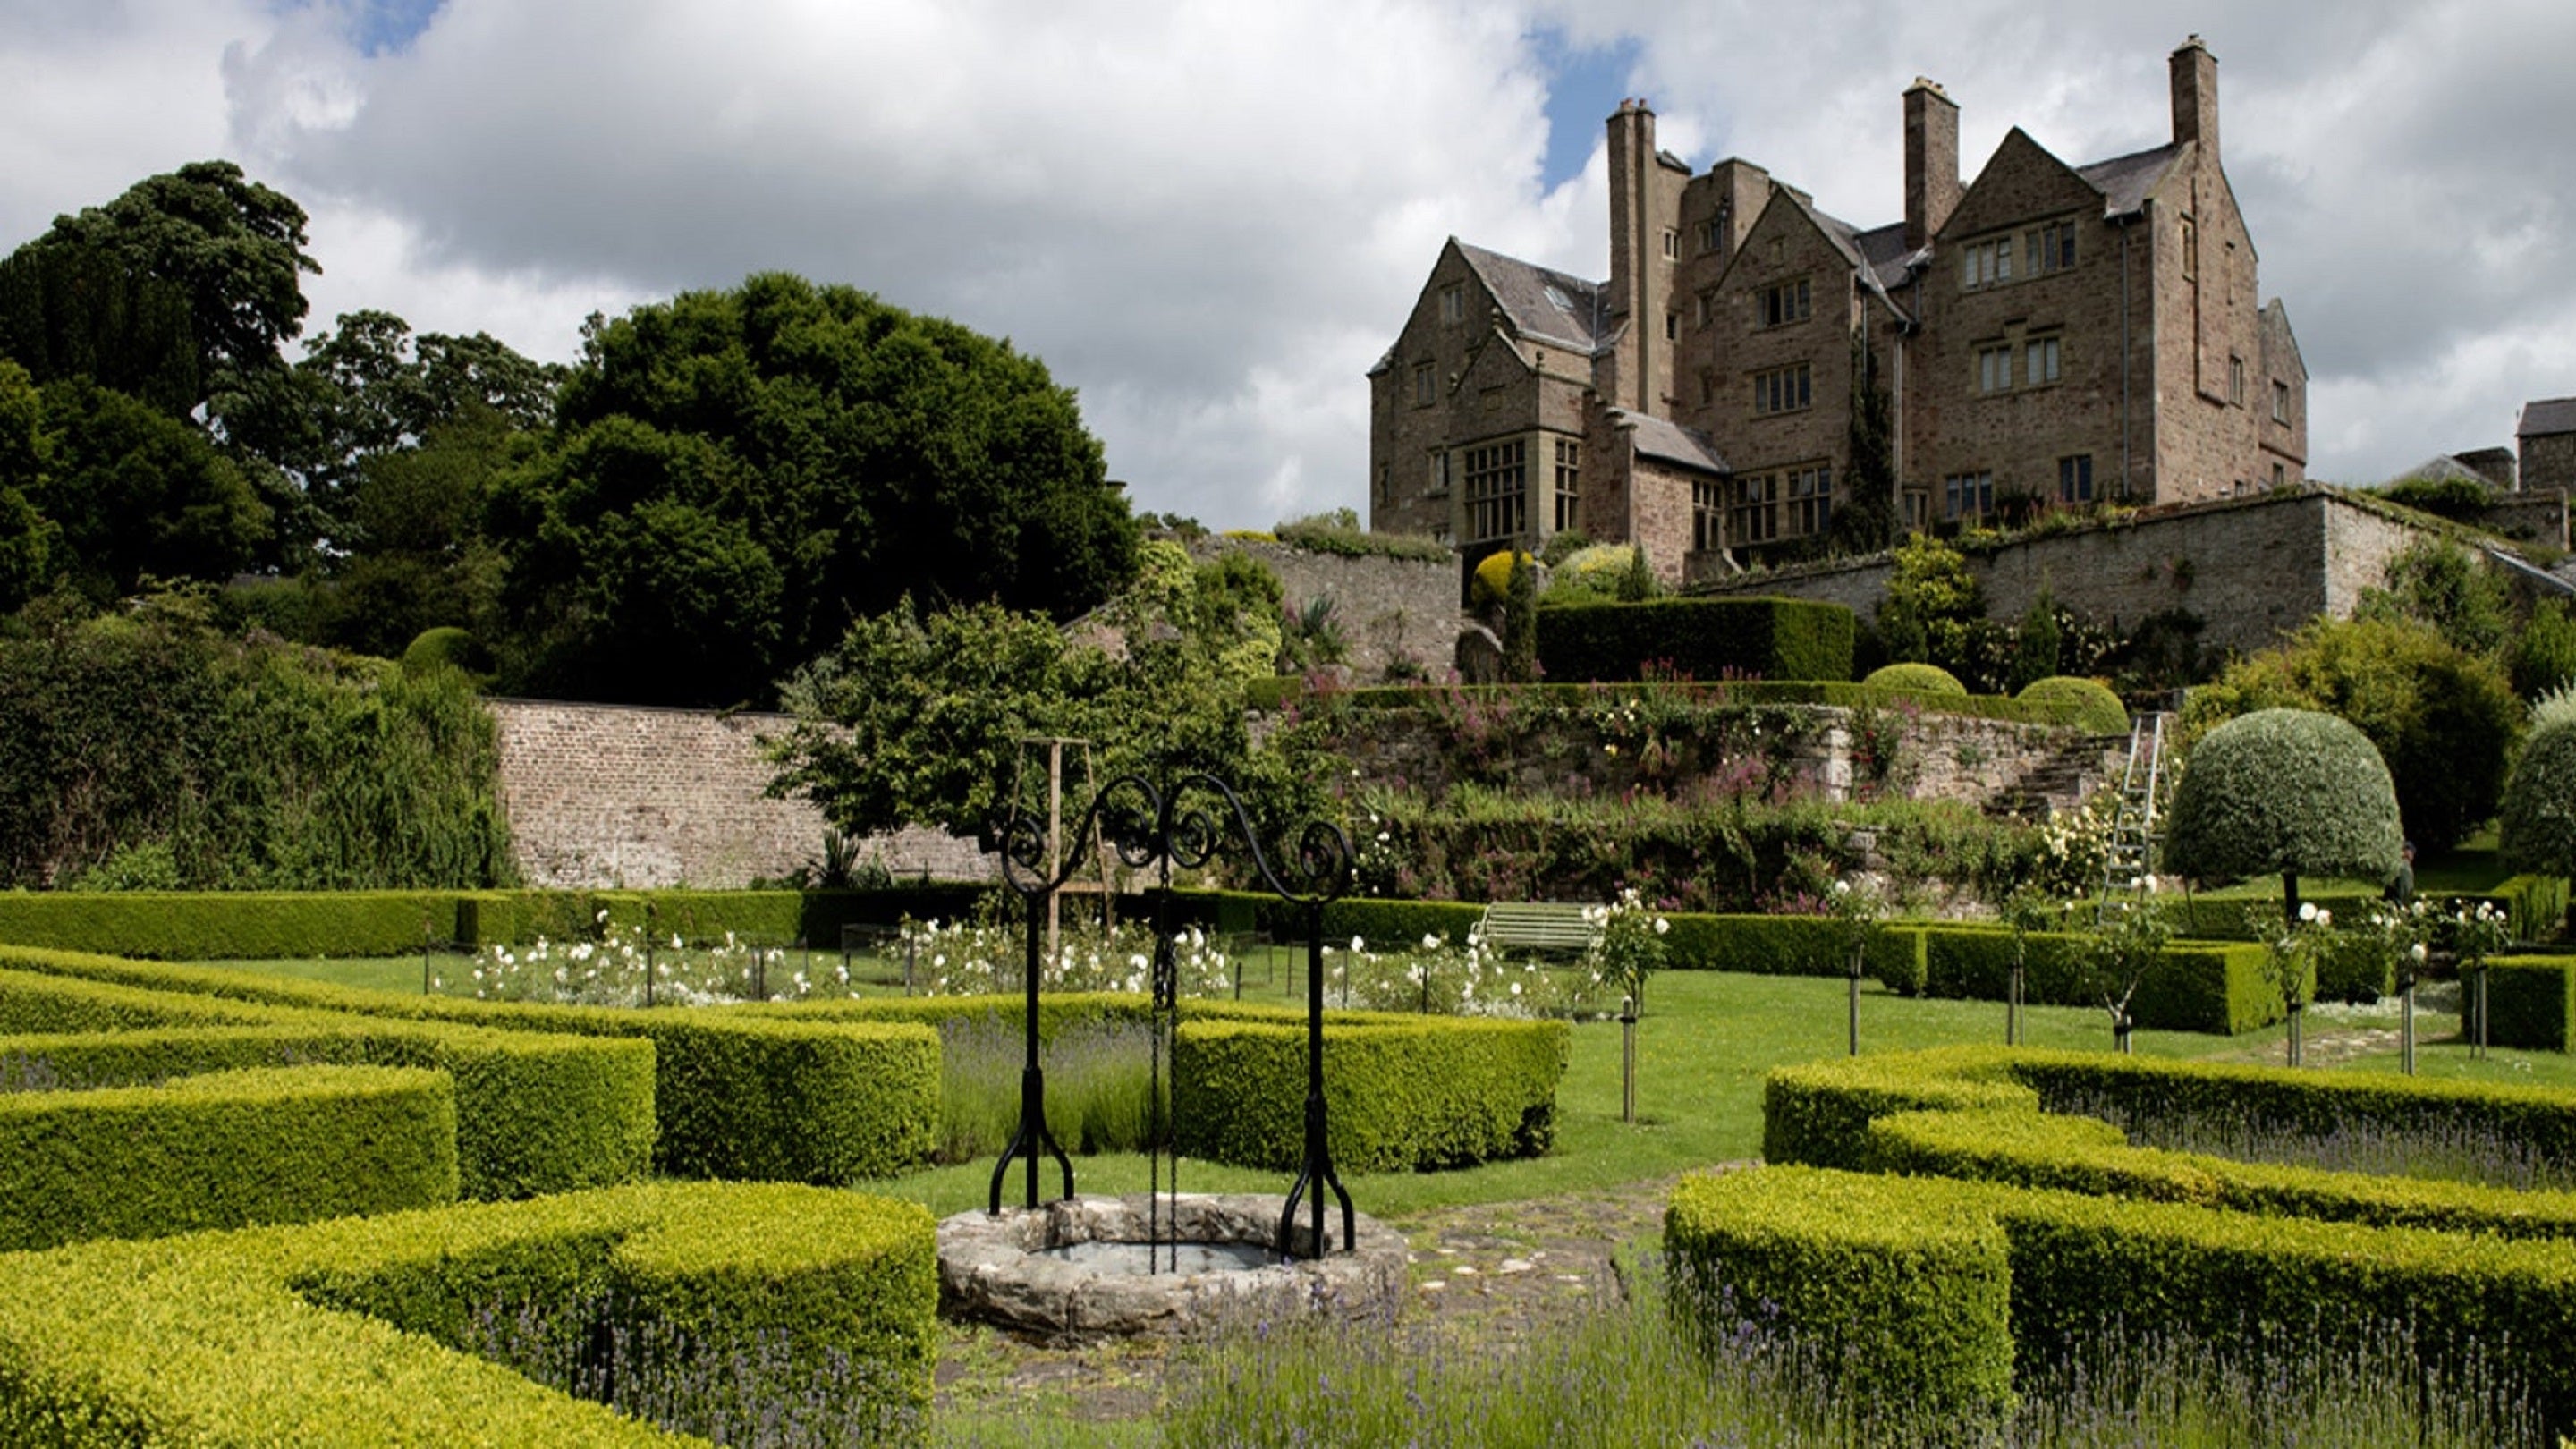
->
[1664,1168,2576,1434]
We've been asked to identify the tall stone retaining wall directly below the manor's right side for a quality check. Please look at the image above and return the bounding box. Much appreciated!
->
[1706,493,2462,649]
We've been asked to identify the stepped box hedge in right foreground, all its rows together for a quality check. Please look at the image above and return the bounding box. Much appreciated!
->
[1666,1046,2576,1434]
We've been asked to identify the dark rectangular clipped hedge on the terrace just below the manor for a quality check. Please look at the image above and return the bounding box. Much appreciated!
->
[1538,598,1855,681]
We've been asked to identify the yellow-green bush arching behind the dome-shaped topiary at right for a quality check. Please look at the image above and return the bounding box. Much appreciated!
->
[2184,619,2522,851]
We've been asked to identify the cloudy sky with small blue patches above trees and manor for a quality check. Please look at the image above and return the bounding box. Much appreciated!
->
[0,0,2576,526]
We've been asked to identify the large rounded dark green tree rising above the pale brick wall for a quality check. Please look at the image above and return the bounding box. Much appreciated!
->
[489,274,1136,704]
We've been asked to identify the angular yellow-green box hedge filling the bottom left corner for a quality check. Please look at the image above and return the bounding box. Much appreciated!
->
[0,1183,937,1446]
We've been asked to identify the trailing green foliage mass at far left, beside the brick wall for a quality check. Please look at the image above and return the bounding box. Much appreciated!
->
[0,601,513,889]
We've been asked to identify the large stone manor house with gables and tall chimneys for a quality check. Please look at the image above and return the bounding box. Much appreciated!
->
[1368,36,2308,582]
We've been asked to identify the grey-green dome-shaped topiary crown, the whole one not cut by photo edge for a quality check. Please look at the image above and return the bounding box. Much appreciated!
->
[2164,709,2403,889]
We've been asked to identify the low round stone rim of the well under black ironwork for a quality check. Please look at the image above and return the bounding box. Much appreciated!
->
[940,1194,1404,1343]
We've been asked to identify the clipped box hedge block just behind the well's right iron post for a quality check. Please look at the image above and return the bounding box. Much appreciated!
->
[1172,1003,1569,1174]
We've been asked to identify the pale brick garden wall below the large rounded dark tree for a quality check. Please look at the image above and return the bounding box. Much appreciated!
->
[484,699,995,889]
